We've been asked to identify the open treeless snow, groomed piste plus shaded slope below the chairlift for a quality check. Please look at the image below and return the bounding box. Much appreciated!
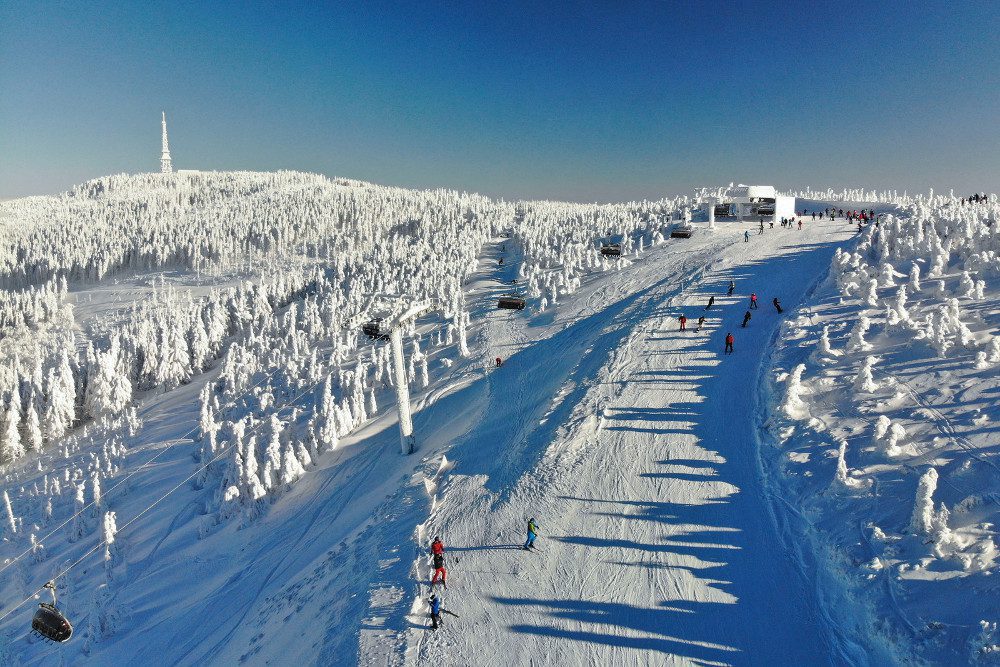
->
[0,176,908,665]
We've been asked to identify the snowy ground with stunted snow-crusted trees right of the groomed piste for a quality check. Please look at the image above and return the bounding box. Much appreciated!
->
[765,197,1000,664]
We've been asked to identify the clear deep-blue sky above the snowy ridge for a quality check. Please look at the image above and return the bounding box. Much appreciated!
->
[0,0,1000,201]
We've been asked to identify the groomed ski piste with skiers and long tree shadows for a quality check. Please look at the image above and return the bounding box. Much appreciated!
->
[392,217,877,665]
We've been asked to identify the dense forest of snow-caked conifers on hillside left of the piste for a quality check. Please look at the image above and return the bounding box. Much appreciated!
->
[0,172,685,604]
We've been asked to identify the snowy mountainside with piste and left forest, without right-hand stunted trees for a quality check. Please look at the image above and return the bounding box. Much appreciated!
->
[0,173,988,665]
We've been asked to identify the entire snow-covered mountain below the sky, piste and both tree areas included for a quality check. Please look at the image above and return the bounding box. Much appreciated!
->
[0,172,1000,666]
